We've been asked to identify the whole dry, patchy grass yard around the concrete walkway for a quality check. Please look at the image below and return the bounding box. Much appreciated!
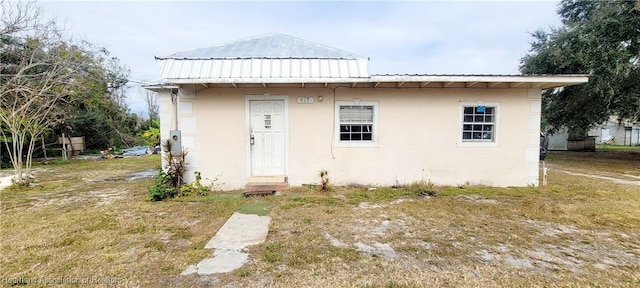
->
[0,151,640,287]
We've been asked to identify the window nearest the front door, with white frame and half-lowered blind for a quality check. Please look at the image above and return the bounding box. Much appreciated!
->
[336,101,378,147]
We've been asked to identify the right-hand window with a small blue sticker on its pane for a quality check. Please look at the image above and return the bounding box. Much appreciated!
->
[462,106,497,142]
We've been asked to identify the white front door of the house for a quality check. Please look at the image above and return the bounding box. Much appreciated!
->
[249,100,286,176]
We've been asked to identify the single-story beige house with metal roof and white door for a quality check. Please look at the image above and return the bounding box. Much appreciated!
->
[147,33,588,189]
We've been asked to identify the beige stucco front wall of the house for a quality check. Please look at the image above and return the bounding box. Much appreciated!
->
[159,87,540,189]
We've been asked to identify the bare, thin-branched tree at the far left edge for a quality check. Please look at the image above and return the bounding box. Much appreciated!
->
[0,1,73,184]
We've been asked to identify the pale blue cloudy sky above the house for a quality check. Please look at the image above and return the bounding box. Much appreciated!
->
[40,0,561,113]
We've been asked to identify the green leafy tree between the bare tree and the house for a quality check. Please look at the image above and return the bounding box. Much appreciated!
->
[55,42,137,150]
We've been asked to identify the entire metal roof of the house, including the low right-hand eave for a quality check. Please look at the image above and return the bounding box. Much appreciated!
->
[151,33,589,89]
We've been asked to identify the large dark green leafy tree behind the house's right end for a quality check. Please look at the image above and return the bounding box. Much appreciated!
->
[520,0,640,138]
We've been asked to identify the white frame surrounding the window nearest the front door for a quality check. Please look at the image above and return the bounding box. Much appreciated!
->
[333,101,380,148]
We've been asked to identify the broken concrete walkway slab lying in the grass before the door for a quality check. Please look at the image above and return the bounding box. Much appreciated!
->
[180,213,271,275]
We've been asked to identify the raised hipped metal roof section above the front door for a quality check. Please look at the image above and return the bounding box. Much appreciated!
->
[156,33,369,83]
